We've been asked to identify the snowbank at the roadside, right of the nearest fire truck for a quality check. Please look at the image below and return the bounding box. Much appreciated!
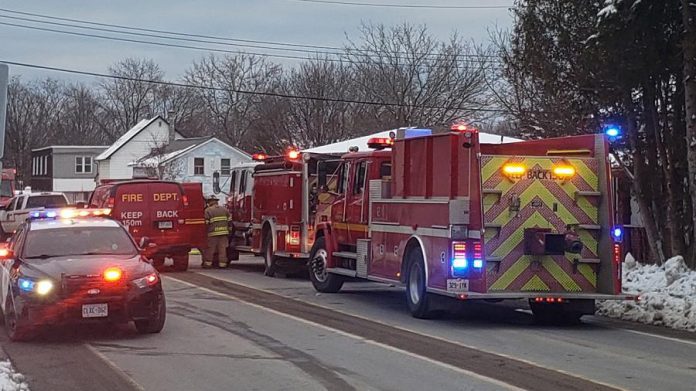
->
[597,254,696,331]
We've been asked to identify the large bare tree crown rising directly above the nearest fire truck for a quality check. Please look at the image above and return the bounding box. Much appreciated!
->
[346,24,489,127]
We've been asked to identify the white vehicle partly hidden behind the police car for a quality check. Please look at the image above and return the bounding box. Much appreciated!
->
[0,192,68,241]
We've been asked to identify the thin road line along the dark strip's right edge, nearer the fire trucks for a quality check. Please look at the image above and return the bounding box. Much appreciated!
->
[189,273,627,390]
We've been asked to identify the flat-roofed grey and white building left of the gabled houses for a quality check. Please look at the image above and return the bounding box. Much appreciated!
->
[31,145,108,203]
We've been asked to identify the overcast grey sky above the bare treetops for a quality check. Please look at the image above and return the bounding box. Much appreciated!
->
[0,0,512,80]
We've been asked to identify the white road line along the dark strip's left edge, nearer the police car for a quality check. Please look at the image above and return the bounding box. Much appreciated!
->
[164,276,523,391]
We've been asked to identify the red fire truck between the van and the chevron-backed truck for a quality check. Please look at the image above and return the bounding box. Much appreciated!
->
[213,150,340,276]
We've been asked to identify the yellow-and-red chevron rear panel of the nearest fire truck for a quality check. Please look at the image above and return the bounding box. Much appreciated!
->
[481,155,604,293]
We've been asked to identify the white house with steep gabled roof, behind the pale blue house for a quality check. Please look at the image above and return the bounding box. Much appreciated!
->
[95,115,184,182]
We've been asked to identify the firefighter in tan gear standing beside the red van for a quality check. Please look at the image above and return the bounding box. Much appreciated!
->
[203,195,231,269]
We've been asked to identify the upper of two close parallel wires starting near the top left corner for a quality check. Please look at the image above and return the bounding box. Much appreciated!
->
[0,8,497,59]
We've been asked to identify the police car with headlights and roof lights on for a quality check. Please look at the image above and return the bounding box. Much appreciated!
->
[0,209,166,340]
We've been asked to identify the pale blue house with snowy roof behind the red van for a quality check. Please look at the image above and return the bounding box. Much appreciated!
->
[129,136,251,201]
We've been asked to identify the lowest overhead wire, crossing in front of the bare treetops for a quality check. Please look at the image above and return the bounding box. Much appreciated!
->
[0,60,505,113]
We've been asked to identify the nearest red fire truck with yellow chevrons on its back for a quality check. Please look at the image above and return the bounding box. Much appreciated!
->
[309,125,630,321]
